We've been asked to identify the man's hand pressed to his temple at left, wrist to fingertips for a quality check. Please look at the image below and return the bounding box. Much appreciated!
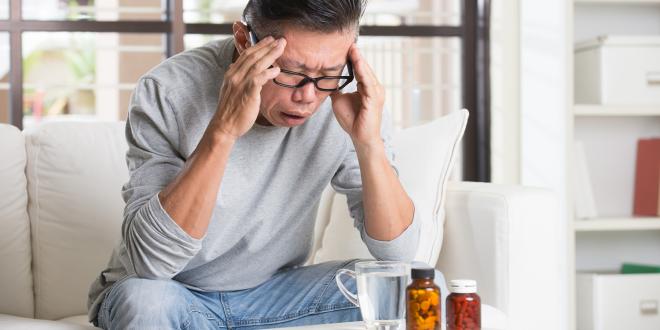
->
[211,37,286,140]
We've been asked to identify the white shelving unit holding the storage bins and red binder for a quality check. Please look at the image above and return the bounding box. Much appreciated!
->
[567,0,660,328]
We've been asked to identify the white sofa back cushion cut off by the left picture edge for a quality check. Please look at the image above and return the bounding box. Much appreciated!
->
[0,124,34,317]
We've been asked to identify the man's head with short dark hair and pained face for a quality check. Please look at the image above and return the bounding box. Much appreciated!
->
[234,0,365,127]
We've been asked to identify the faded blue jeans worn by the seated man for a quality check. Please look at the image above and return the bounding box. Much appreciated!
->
[97,260,446,329]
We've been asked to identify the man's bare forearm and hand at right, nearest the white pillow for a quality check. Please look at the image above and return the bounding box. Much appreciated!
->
[331,45,414,241]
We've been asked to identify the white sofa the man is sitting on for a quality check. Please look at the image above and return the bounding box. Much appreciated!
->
[0,122,562,330]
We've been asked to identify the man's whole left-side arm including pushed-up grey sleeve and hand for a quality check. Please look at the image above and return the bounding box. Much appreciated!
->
[122,38,284,279]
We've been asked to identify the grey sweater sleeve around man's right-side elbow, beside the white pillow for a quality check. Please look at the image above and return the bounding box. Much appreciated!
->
[331,112,420,261]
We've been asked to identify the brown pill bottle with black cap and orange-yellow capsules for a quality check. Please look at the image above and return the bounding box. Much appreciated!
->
[406,268,442,330]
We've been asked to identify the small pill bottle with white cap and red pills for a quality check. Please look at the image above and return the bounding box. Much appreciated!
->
[447,280,481,330]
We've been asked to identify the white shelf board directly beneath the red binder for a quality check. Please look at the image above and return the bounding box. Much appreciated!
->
[574,217,660,232]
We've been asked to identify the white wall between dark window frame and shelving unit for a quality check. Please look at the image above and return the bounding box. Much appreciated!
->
[491,0,574,329]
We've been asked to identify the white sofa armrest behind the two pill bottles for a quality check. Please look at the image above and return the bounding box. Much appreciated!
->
[437,182,564,330]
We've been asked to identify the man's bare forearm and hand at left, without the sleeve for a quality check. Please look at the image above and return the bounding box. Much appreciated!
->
[159,37,286,238]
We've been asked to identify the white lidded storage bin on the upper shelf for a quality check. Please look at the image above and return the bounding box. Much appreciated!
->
[574,36,660,105]
